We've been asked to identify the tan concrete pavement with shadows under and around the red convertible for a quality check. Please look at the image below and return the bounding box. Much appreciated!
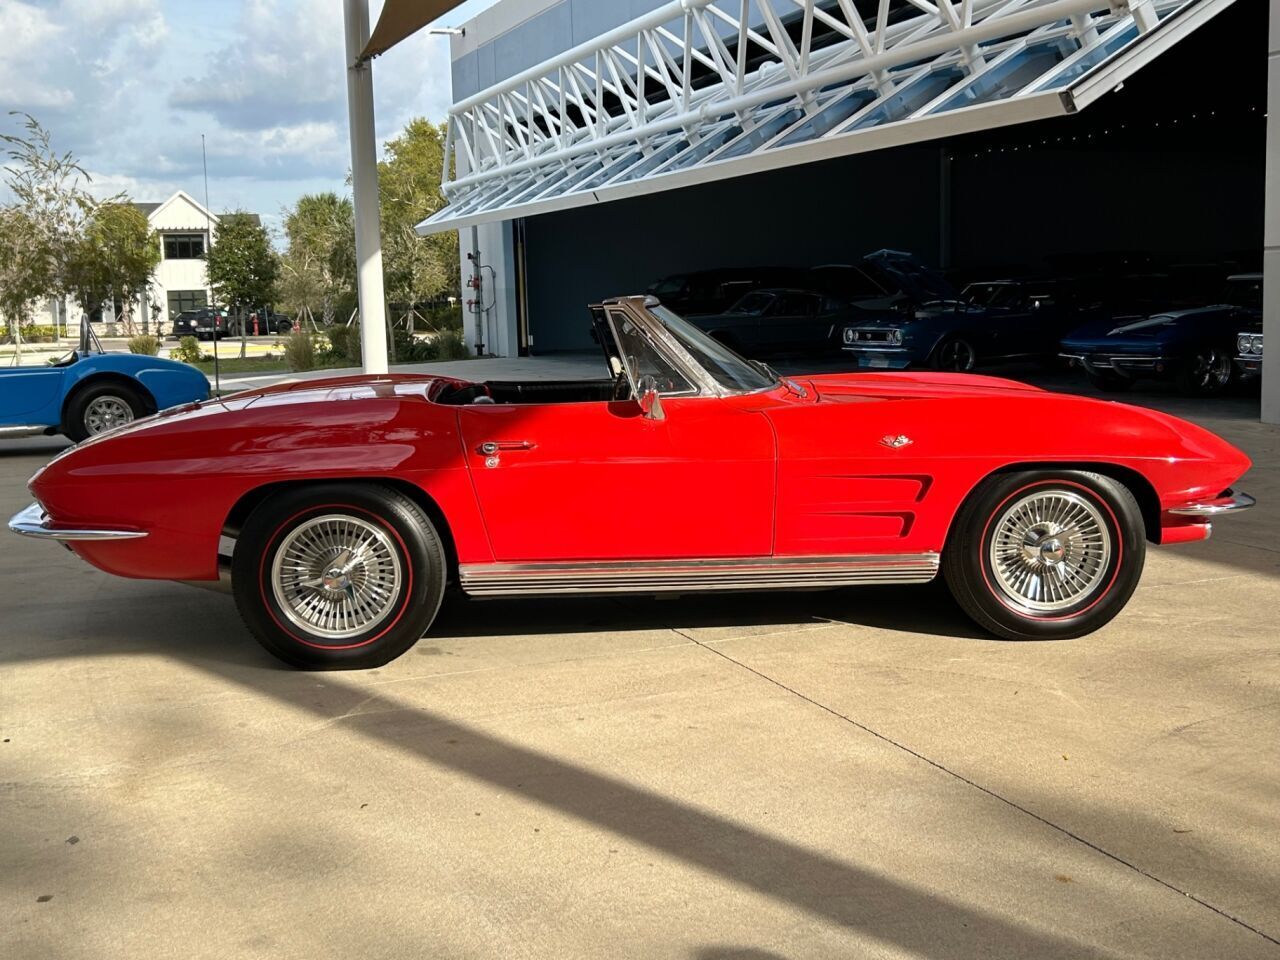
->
[0,386,1280,960]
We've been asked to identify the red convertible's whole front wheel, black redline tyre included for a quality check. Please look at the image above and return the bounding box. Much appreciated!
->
[942,470,1147,640]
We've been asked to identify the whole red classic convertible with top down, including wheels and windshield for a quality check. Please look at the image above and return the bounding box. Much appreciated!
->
[10,298,1253,668]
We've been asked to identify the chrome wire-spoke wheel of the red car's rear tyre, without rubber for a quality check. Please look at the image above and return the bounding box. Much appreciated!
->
[271,513,404,644]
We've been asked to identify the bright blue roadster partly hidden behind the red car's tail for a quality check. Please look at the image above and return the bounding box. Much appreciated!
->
[0,324,209,443]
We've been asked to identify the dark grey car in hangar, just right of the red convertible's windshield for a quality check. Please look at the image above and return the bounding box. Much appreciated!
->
[685,288,876,357]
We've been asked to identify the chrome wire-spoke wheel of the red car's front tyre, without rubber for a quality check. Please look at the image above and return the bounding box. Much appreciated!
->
[988,489,1112,616]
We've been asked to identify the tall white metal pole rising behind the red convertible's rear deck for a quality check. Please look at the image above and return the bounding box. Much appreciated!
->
[343,0,387,374]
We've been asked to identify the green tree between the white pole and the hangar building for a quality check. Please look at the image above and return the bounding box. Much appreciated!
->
[378,116,460,327]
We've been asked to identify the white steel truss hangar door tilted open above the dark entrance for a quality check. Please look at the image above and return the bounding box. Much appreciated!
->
[417,0,1233,234]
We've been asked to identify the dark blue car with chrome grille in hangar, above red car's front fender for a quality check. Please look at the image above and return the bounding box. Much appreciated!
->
[842,279,1079,372]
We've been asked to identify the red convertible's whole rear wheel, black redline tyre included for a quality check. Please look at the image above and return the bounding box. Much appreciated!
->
[232,484,447,669]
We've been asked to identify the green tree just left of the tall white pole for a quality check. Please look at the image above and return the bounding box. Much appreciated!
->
[280,193,356,325]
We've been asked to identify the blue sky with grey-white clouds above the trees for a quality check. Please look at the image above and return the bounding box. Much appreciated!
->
[0,0,494,235]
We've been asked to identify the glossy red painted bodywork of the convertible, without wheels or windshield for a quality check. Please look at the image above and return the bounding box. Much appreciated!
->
[31,372,1249,580]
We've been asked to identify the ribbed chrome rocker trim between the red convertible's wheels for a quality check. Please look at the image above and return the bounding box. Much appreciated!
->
[458,553,938,596]
